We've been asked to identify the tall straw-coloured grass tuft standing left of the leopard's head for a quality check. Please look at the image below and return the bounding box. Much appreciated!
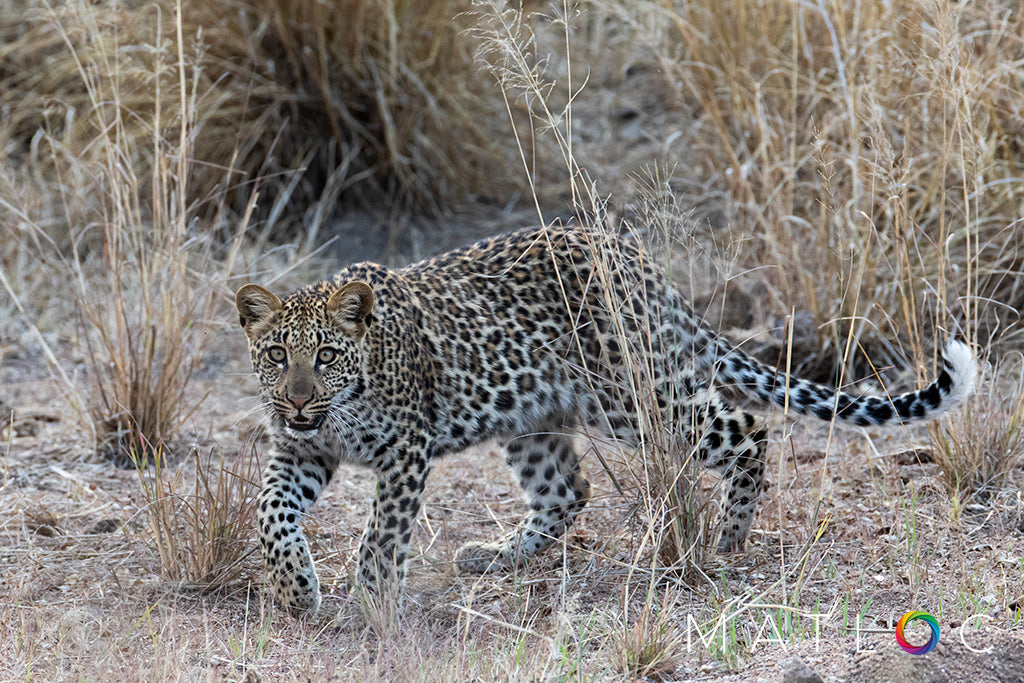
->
[5,2,251,462]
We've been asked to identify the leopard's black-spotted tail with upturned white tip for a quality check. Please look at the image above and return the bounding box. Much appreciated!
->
[716,341,978,426]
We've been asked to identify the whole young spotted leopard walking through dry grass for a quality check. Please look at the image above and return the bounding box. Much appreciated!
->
[234,224,976,615]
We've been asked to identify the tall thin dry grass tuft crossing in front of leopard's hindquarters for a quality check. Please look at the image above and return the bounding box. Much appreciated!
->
[477,2,714,579]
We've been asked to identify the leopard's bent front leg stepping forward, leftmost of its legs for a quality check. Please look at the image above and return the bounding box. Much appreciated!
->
[256,451,333,615]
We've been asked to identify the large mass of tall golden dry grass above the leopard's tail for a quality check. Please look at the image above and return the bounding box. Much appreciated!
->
[592,0,1024,380]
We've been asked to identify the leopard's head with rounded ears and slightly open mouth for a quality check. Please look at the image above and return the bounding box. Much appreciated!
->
[234,282,374,434]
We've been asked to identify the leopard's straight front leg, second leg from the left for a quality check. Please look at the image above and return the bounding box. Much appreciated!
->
[356,447,430,594]
